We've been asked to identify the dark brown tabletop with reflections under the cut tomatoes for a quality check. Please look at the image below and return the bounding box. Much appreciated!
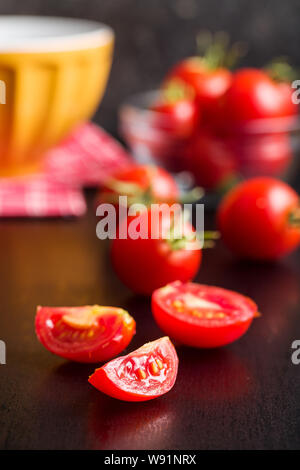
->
[0,192,300,449]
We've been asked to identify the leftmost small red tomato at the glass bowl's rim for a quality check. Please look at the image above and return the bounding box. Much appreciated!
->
[151,99,200,139]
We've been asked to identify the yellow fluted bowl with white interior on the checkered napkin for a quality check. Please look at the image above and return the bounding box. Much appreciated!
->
[0,16,114,176]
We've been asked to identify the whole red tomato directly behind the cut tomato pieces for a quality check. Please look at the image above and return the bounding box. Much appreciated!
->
[111,210,202,295]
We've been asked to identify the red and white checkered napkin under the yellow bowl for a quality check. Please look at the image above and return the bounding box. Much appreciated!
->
[0,123,130,217]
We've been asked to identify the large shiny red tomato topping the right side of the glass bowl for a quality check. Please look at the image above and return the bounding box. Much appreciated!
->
[221,68,298,128]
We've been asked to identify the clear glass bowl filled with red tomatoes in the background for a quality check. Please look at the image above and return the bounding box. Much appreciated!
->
[119,91,300,204]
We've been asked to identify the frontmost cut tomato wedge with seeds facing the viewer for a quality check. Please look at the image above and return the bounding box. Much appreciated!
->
[89,336,178,401]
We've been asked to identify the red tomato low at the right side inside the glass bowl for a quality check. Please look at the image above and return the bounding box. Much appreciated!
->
[232,133,293,177]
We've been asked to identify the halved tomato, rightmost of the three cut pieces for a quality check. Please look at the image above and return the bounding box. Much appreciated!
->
[152,281,257,348]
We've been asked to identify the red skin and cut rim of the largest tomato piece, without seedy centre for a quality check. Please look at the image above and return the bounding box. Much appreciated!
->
[152,282,257,348]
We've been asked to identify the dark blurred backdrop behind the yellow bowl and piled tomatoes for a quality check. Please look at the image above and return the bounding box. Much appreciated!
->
[0,0,300,133]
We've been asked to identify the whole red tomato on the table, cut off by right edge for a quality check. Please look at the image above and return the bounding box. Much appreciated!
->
[218,177,300,259]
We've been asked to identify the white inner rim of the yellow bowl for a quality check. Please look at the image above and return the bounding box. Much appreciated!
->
[0,15,114,54]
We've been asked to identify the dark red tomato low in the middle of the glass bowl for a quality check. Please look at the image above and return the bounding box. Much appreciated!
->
[183,131,237,190]
